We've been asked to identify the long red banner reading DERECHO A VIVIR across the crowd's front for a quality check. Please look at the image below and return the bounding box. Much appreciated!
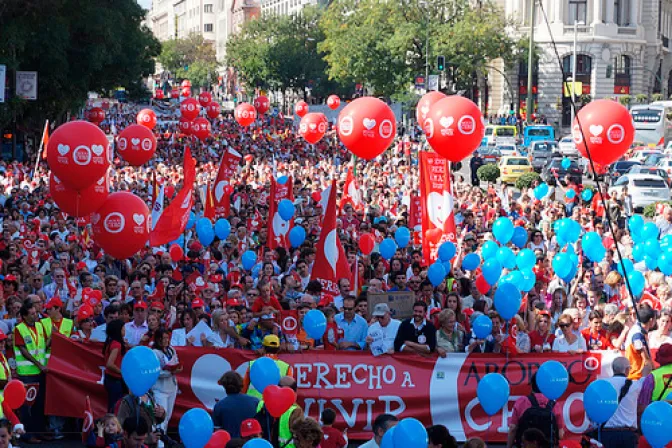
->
[46,336,618,442]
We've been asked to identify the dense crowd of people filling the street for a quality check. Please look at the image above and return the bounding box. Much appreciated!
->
[0,98,672,447]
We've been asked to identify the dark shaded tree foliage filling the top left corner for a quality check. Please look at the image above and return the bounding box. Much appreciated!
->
[0,0,160,130]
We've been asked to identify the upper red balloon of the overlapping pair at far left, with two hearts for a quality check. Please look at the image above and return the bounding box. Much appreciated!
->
[47,120,110,191]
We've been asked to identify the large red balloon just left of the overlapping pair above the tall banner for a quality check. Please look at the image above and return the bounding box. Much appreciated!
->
[338,96,397,160]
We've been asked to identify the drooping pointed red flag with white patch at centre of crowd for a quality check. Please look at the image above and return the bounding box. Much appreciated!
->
[310,180,352,296]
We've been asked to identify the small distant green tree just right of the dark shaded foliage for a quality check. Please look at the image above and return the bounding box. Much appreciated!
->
[157,34,219,87]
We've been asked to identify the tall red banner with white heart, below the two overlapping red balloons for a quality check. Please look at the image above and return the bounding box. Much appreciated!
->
[420,151,457,263]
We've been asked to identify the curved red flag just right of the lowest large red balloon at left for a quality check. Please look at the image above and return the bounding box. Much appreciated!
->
[149,147,196,247]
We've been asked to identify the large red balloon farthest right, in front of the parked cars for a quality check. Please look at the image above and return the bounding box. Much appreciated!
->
[572,100,635,165]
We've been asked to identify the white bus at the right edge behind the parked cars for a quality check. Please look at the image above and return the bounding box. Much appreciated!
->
[630,101,672,146]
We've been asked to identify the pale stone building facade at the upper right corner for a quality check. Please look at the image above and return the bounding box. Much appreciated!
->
[488,0,672,127]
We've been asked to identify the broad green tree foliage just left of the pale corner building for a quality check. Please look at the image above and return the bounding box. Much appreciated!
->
[319,0,514,96]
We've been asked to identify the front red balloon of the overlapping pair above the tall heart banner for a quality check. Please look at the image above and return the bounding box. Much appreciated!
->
[422,95,485,163]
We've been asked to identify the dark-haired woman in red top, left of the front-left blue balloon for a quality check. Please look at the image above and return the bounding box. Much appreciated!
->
[103,319,126,413]
